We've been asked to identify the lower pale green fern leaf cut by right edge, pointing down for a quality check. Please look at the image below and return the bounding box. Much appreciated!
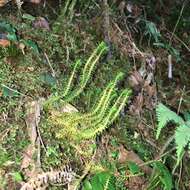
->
[175,124,190,163]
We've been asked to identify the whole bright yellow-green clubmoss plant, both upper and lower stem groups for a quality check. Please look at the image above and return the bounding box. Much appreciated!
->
[45,43,131,148]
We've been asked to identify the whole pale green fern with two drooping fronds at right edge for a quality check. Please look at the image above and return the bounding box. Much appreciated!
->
[156,103,190,164]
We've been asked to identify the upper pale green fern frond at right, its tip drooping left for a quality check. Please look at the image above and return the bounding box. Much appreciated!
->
[156,103,184,139]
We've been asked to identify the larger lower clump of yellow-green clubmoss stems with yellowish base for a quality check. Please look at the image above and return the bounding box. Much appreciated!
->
[51,73,130,142]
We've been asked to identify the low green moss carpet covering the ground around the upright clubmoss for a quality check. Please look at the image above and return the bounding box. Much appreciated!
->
[0,2,189,190]
